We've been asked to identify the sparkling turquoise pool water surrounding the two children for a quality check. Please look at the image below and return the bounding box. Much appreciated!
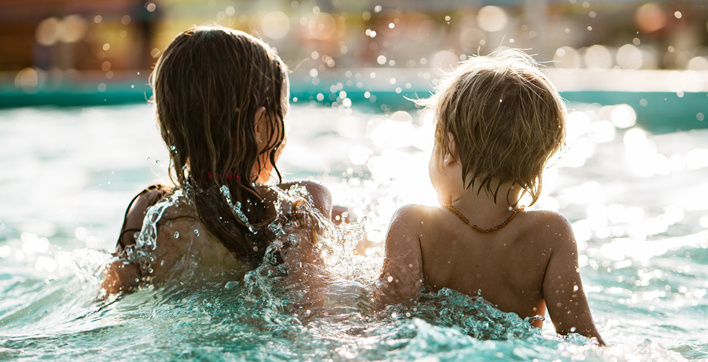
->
[0,105,708,361]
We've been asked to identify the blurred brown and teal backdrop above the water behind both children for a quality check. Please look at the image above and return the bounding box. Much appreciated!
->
[0,0,708,132]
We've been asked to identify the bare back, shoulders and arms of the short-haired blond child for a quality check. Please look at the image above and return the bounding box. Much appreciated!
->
[380,205,599,336]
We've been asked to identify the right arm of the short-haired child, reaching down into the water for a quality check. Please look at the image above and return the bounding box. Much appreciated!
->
[543,215,605,346]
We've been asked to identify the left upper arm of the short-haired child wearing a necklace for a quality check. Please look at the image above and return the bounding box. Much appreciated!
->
[374,205,423,308]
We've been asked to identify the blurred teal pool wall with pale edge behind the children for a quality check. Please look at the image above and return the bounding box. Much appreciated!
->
[0,69,708,133]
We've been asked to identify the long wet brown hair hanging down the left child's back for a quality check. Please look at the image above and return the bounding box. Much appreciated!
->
[152,27,287,266]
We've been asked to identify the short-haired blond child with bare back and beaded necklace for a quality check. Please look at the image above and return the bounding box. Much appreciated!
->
[376,50,604,345]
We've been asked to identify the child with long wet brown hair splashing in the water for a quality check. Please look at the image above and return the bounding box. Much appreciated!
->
[101,27,332,302]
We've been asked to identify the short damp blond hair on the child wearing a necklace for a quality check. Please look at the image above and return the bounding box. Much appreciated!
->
[424,50,565,204]
